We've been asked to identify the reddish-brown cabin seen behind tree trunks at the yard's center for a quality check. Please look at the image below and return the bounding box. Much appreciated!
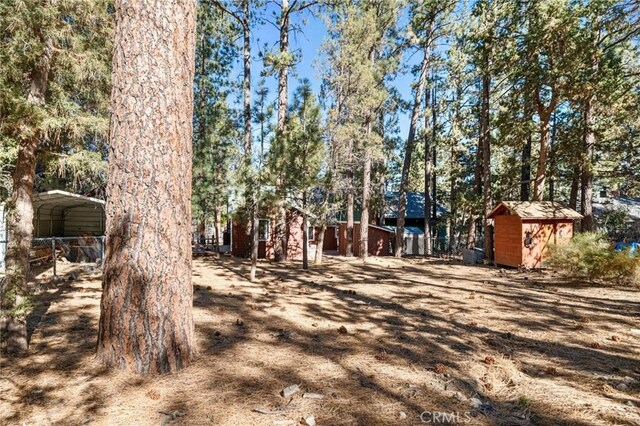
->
[231,207,338,260]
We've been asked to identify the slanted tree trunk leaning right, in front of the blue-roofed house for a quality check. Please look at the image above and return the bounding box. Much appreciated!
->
[394,47,430,257]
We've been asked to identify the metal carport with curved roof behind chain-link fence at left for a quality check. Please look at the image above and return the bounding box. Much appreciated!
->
[0,189,105,271]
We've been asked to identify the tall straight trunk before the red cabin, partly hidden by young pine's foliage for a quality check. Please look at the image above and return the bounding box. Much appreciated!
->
[274,0,290,262]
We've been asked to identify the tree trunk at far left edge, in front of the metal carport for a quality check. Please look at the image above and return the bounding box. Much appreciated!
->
[0,36,53,352]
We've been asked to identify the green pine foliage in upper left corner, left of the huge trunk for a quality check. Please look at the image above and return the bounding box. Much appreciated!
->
[0,0,114,199]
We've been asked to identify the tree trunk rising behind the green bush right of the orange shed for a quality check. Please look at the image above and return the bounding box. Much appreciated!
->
[580,96,596,232]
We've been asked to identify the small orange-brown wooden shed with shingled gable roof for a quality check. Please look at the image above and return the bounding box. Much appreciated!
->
[489,201,582,268]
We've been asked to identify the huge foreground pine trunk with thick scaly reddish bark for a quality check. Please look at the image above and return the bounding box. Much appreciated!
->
[97,0,196,374]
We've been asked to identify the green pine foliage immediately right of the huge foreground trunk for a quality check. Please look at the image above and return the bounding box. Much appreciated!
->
[191,6,241,228]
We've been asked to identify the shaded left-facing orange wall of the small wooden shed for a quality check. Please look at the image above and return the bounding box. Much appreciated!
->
[494,215,524,267]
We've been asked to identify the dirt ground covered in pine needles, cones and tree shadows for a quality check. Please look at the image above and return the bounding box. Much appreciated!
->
[0,257,640,425]
